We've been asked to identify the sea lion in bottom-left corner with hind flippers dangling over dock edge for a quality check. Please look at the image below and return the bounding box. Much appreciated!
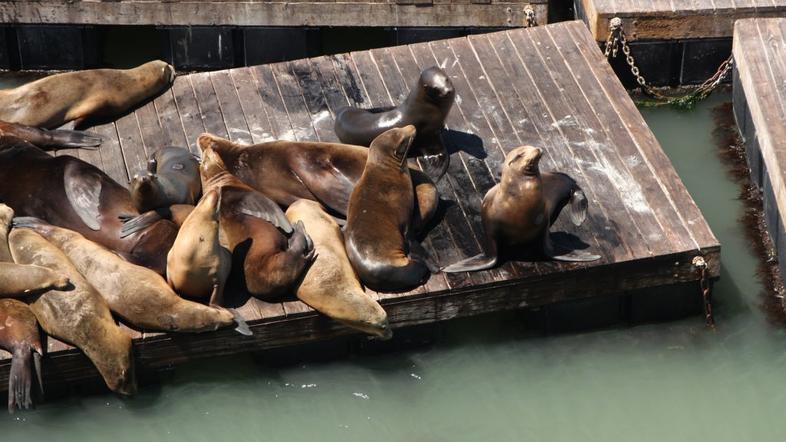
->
[0,299,44,413]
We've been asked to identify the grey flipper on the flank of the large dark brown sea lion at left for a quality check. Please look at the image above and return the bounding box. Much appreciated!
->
[63,162,102,230]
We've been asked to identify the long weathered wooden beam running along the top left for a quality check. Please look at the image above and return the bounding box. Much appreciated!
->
[0,0,548,27]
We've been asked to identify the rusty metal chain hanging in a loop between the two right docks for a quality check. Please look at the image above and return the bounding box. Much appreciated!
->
[604,17,734,109]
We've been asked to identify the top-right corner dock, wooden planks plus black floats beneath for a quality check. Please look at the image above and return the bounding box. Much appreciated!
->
[574,0,786,87]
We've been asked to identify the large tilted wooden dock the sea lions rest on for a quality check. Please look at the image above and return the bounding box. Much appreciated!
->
[0,22,720,394]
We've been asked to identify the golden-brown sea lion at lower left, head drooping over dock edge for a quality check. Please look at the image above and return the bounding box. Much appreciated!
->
[9,229,136,395]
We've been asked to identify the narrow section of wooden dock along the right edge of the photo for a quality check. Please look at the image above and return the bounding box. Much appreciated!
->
[734,18,786,275]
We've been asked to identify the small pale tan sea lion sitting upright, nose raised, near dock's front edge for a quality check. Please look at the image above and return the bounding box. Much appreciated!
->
[166,190,232,305]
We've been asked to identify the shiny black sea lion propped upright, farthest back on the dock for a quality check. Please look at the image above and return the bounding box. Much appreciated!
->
[335,66,456,180]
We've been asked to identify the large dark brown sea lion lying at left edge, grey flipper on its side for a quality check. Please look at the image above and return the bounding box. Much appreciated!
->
[0,136,177,275]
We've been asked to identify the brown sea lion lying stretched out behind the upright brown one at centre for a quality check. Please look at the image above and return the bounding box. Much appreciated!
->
[199,134,439,231]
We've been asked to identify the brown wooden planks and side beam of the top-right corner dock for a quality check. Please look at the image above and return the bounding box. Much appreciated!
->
[574,0,786,41]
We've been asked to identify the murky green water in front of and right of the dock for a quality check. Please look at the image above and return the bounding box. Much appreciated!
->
[0,91,786,442]
